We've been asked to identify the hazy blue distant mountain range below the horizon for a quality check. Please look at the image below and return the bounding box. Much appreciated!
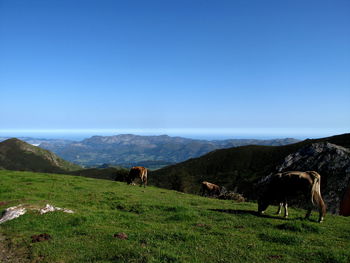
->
[0,134,298,169]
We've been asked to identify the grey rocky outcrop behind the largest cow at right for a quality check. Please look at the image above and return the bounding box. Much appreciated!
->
[276,142,350,215]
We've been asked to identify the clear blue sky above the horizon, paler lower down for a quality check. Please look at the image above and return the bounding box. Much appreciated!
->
[0,0,350,137]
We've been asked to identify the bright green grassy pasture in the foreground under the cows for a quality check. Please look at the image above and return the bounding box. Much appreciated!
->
[0,171,350,263]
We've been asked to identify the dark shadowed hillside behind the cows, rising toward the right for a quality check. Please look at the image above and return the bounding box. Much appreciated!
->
[150,134,350,198]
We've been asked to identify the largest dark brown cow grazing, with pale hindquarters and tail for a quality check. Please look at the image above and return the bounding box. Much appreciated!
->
[258,171,326,223]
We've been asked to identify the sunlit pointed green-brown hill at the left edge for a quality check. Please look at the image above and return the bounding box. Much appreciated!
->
[0,138,81,173]
